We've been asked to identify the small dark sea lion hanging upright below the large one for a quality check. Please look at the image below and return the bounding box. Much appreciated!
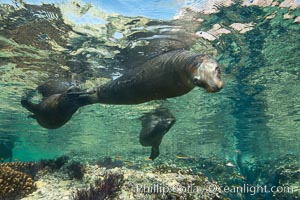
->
[140,108,176,160]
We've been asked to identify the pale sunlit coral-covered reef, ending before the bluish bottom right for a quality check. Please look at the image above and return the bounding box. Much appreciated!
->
[0,156,221,200]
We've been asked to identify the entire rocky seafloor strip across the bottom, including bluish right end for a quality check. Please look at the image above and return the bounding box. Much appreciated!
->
[0,155,300,200]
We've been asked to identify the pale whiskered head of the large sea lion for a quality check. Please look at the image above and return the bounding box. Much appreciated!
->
[192,55,224,92]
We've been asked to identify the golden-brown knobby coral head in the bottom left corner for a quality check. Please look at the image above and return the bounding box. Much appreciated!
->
[0,166,36,199]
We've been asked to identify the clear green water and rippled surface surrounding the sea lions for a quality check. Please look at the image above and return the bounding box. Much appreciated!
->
[0,0,300,198]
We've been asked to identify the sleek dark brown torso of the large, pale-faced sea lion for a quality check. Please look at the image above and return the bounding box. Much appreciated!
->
[90,50,223,104]
